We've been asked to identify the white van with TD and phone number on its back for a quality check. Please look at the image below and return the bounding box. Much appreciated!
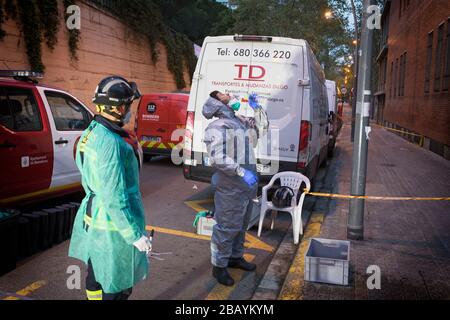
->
[184,35,328,182]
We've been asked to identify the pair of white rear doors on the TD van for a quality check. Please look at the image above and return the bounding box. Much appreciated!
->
[189,37,305,172]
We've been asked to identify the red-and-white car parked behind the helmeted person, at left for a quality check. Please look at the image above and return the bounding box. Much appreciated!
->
[0,71,142,206]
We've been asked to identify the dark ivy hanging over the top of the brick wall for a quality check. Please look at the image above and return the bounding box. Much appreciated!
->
[0,0,197,89]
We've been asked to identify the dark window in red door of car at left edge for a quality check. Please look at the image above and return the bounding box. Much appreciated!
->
[0,87,42,132]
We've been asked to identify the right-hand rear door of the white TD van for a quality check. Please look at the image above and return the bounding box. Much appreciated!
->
[248,40,306,170]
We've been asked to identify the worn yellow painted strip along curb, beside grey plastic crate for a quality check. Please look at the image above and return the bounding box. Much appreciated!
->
[278,213,324,300]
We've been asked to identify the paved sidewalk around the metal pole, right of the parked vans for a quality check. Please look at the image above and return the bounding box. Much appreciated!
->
[279,120,450,300]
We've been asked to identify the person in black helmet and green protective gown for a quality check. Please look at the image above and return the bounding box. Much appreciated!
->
[69,76,151,300]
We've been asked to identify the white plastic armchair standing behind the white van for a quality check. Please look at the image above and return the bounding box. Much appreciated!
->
[258,171,311,244]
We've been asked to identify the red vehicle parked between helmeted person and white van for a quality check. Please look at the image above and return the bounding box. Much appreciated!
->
[135,93,189,161]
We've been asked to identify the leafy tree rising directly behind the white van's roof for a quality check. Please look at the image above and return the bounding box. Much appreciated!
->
[229,0,351,79]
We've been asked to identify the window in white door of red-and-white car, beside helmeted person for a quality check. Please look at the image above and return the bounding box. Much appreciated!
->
[45,91,92,131]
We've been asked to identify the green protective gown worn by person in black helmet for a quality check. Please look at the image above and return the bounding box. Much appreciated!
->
[69,116,148,293]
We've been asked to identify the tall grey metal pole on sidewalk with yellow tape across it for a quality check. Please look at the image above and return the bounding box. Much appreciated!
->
[347,0,374,240]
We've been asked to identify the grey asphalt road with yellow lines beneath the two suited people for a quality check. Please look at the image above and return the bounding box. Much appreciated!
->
[0,157,290,300]
